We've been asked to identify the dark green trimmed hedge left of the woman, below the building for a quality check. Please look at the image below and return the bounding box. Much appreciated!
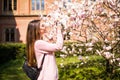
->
[0,43,25,63]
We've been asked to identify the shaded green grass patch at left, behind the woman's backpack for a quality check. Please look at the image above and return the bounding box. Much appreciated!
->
[0,59,29,80]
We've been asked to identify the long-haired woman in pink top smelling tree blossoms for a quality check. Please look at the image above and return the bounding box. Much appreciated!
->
[26,20,63,80]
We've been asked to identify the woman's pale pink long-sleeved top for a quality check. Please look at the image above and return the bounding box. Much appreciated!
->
[34,31,63,80]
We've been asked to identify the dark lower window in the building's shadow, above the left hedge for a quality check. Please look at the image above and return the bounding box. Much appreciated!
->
[5,28,15,42]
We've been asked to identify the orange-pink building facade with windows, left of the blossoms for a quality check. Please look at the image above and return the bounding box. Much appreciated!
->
[0,0,57,43]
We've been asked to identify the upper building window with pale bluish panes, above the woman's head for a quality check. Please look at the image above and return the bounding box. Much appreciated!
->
[31,0,45,10]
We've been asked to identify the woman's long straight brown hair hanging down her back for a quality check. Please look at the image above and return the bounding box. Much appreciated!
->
[26,20,40,66]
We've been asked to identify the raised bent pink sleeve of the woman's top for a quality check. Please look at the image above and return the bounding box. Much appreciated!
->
[35,30,63,52]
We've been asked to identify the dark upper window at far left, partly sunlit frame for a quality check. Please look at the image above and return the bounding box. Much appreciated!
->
[3,0,17,11]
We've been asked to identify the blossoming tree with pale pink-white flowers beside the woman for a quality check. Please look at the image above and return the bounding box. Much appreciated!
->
[41,0,120,73]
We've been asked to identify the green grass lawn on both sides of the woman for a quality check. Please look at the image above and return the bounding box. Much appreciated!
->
[0,55,118,80]
